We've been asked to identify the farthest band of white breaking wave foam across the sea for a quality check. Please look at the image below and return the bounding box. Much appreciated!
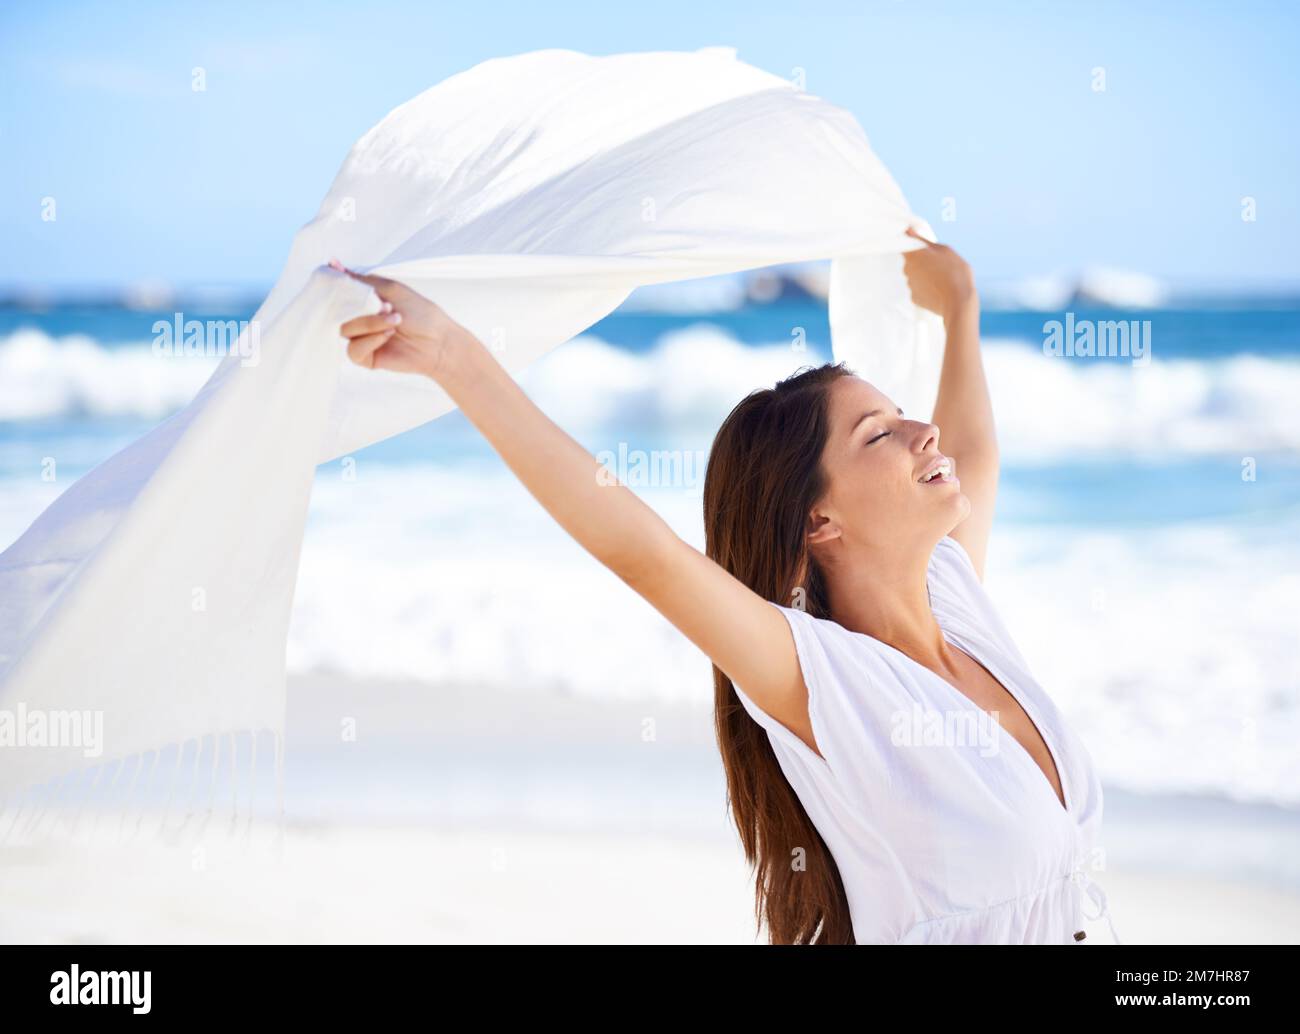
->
[0,323,1300,460]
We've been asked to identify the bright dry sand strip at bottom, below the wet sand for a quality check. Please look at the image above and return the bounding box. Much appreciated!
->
[10,826,1300,944]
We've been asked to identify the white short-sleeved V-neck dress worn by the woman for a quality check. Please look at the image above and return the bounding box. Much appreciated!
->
[736,537,1119,944]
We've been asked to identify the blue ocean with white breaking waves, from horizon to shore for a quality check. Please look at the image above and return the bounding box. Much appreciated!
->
[0,299,1300,809]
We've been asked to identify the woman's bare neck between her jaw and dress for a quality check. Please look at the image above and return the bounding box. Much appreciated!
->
[824,549,949,667]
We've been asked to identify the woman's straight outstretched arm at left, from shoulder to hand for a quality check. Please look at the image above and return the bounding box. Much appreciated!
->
[341,266,818,750]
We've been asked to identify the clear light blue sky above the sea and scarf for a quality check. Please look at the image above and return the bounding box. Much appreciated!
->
[0,0,1300,289]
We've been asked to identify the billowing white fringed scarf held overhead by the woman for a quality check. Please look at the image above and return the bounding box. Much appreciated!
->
[0,48,941,842]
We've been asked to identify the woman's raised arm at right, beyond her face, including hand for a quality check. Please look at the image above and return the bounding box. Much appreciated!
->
[904,230,998,580]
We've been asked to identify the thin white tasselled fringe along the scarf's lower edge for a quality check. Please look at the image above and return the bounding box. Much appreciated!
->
[0,728,285,864]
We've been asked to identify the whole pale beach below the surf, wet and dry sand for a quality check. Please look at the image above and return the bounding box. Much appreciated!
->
[0,676,1300,944]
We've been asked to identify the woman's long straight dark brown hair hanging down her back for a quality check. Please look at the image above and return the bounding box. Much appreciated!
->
[705,363,854,944]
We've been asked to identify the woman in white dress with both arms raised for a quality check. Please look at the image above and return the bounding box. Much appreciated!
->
[327,232,1109,943]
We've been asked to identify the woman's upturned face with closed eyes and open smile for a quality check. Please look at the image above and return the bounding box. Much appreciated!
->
[810,377,970,553]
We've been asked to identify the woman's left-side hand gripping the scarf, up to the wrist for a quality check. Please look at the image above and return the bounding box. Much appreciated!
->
[330,263,473,381]
